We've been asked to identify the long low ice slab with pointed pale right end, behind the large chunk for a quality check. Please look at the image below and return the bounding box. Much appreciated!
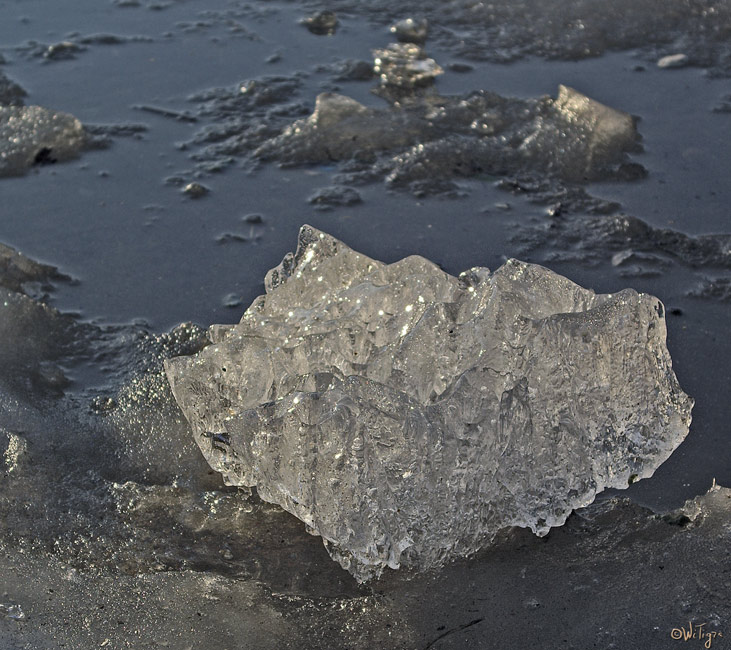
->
[255,83,644,187]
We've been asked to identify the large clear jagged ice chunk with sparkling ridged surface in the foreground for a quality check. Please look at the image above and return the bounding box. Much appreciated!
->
[165,226,693,580]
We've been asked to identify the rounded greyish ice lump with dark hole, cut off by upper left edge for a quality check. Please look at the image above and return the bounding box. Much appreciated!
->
[0,105,87,177]
